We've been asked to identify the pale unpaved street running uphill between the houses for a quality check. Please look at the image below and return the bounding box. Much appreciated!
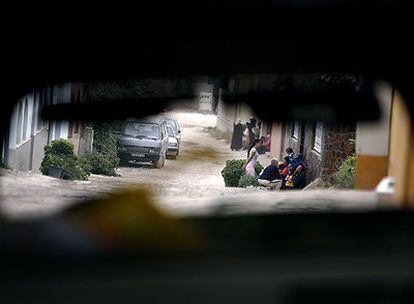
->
[0,113,376,218]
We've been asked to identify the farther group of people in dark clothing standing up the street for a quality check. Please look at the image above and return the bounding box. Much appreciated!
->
[230,117,271,154]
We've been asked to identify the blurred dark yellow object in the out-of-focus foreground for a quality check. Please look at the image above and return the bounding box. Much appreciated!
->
[67,189,200,252]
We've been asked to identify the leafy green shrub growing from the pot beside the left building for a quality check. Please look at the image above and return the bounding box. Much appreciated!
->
[40,139,90,180]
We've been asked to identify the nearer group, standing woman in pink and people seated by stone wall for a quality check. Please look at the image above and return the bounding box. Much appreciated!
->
[242,139,306,190]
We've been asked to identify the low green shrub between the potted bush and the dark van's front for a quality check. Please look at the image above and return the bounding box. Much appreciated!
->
[80,152,119,176]
